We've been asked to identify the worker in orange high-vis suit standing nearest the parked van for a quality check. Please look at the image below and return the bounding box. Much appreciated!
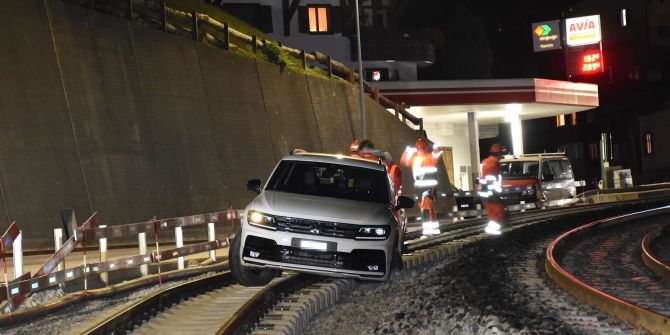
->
[479,143,505,235]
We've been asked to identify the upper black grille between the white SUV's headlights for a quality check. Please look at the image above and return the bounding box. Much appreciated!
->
[275,216,360,239]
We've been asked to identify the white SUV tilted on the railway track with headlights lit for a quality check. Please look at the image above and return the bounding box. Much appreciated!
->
[230,151,414,286]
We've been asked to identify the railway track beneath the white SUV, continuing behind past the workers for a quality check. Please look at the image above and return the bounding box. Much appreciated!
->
[79,198,670,334]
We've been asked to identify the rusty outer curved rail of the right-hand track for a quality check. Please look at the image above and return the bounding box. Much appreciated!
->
[545,206,670,334]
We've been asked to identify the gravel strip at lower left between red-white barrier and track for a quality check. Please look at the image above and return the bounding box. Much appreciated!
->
[0,272,218,335]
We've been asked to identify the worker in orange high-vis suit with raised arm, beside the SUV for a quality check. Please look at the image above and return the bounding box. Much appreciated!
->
[400,138,442,236]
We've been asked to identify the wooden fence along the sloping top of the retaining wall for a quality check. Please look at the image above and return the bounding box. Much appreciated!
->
[64,0,423,131]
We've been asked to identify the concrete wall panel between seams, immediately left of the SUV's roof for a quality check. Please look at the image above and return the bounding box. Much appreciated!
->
[198,45,276,208]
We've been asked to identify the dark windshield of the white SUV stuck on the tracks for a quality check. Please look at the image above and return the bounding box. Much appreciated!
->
[266,160,389,203]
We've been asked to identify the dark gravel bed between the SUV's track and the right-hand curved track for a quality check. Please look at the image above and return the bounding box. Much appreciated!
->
[306,211,633,334]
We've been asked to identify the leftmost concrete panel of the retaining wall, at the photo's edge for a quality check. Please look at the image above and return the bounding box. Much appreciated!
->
[0,0,89,244]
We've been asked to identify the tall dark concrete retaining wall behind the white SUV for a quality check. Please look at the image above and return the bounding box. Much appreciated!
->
[0,0,426,248]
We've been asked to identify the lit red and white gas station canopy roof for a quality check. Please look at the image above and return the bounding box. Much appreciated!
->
[379,78,598,124]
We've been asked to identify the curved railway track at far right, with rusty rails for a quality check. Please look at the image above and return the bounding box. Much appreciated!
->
[546,206,670,334]
